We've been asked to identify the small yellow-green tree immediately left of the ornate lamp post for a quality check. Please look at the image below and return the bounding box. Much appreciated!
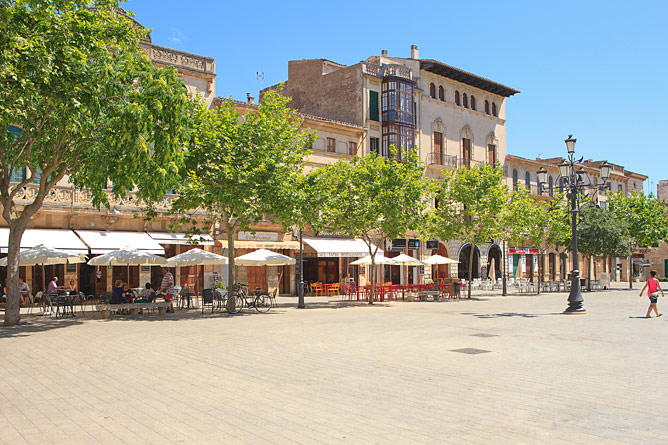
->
[504,188,570,294]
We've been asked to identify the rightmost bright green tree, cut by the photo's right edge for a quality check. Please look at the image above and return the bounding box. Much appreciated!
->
[608,190,668,289]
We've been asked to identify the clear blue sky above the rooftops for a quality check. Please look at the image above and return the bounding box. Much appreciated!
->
[124,0,668,193]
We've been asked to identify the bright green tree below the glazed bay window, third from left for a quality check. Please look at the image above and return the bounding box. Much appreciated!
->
[307,146,432,304]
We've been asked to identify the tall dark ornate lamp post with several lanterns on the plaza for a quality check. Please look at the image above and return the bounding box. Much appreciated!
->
[538,134,611,314]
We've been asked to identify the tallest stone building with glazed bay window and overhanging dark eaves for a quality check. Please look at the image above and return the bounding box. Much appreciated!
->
[265,45,518,283]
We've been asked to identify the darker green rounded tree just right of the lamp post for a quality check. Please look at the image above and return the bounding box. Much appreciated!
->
[577,205,630,286]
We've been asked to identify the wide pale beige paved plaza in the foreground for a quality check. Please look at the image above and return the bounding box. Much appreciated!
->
[0,290,668,444]
